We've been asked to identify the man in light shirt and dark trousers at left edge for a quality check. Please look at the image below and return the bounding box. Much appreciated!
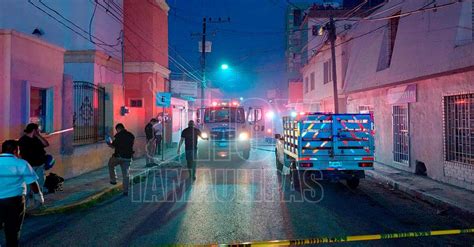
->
[0,140,44,246]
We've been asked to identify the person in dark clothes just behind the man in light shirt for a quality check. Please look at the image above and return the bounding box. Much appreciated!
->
[18,123,49,193]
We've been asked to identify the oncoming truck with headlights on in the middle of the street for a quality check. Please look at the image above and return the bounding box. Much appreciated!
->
[197,101,251,160]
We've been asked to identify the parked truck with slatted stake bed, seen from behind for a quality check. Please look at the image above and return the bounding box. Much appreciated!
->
[275,113,375,188]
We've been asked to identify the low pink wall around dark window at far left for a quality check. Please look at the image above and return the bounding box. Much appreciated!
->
[0,29,64,139]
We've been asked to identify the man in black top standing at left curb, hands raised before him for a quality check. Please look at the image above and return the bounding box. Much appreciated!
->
[107,123,135,196]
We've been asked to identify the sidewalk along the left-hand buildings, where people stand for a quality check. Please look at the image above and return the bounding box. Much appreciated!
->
[28,148,178,215]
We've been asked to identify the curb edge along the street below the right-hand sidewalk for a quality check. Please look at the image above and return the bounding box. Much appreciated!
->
[366,171,474,214]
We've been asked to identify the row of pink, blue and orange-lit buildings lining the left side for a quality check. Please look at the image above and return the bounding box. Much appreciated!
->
[0,0,171,178]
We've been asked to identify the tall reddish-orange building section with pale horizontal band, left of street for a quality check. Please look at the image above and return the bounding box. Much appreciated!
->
[124,0,171,140]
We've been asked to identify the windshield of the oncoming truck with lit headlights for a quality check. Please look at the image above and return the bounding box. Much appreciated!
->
[204,107,245,123]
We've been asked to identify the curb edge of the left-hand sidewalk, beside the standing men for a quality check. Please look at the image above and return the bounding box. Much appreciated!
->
[27,154,180,216]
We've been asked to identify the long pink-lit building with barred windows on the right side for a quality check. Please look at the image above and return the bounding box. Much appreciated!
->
[304,1,474,190]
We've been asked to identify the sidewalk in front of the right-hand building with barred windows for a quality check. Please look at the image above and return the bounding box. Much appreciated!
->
[366,163,474,214]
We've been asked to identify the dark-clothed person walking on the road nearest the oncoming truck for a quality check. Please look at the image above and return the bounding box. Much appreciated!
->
[178,120,206,180]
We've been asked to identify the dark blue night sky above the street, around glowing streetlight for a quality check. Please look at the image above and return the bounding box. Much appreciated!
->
[167,0,334,97]
